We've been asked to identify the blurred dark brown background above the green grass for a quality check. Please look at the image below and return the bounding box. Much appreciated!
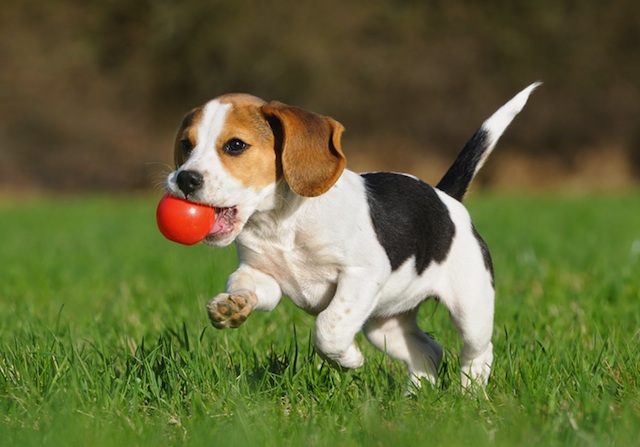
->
[0,0,640,194]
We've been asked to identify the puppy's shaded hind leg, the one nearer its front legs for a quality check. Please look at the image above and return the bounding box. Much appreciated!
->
[363,308,442,387]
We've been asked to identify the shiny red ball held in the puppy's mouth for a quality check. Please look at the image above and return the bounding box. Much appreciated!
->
[156,194,216,245]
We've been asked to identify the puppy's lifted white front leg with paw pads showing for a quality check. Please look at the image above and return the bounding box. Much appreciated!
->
[207,265,282,329]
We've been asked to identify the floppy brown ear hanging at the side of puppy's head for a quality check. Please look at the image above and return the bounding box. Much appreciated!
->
[262,102,346,197]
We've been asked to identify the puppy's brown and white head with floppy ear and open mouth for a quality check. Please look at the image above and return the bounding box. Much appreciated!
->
[166,94,345,246]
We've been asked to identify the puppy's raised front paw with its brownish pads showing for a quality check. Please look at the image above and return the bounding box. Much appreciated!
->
[207,290,258,329]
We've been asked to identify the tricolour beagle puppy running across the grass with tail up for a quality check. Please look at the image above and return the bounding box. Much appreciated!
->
[166,83,539,387]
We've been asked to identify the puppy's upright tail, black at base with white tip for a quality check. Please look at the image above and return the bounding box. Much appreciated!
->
[436,82,542,201]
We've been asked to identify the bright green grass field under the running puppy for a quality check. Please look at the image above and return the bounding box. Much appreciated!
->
[0,192,640,447]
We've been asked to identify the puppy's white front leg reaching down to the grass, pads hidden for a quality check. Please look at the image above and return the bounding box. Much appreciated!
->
[314,277,379,369]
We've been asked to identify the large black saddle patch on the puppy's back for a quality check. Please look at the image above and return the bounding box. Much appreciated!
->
[362,172,456,274]
